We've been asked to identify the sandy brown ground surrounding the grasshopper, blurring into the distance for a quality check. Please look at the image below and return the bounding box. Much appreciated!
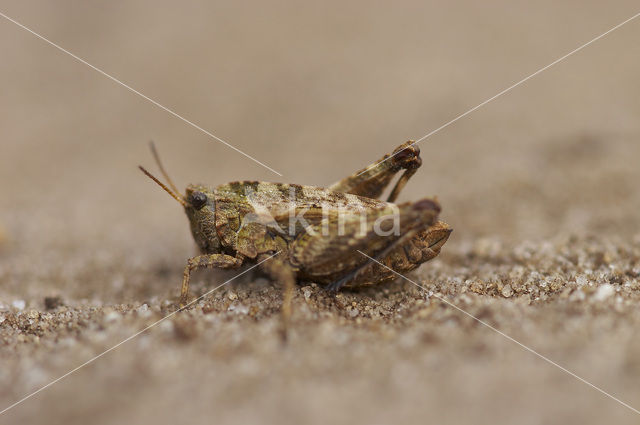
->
[0,1,640,424]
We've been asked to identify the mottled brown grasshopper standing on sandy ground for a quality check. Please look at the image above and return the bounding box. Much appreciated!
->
[140,141,452,324]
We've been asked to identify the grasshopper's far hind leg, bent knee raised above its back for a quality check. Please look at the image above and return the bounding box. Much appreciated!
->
[329,141,422,202]
